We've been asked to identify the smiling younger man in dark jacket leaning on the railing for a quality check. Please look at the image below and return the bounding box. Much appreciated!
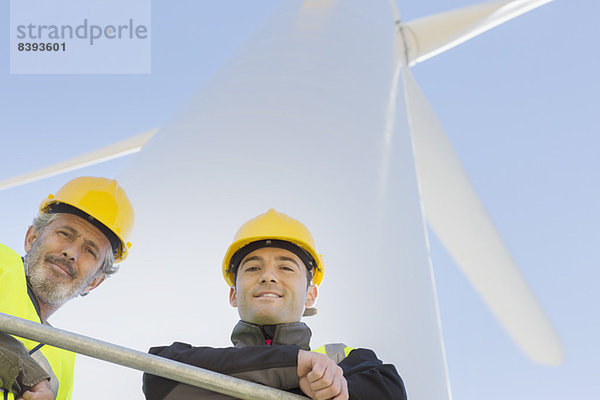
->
[144,209,406,400]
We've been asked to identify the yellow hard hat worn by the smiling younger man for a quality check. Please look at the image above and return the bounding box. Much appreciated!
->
[223,208,323,286]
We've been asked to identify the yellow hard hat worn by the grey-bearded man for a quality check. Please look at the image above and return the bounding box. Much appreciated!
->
[40,176,134,262]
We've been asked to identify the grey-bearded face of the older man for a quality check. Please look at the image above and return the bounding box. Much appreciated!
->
[25,214,110,305]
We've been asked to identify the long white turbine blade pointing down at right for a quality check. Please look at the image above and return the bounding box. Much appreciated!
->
[404,69,563,365]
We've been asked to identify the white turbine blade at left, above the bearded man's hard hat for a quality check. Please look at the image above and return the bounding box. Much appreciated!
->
[0,128,158,190]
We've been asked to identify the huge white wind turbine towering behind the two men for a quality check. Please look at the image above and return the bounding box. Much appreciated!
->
[0,0,562,399]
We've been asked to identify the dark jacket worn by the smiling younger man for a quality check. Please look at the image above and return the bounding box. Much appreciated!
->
[143,321,406,400]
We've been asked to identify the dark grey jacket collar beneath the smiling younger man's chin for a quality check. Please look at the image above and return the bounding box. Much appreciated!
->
[231,321,312,350]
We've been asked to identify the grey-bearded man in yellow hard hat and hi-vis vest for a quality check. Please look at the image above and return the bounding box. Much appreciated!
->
[0,177,134,400]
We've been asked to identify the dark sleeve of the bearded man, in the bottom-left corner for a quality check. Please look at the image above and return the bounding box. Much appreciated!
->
[0,332,50,394]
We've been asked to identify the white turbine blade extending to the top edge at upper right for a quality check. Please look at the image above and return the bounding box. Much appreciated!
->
[402,0,552,65]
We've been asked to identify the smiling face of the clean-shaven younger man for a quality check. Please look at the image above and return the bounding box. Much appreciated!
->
[229,247,317,325]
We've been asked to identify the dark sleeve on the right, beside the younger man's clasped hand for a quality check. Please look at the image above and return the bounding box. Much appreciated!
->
[338,349,407,400]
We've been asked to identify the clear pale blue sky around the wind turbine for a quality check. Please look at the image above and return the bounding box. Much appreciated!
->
[0,0,600,400]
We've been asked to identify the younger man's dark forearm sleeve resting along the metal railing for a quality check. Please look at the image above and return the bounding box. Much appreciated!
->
[142,342,300,400]
